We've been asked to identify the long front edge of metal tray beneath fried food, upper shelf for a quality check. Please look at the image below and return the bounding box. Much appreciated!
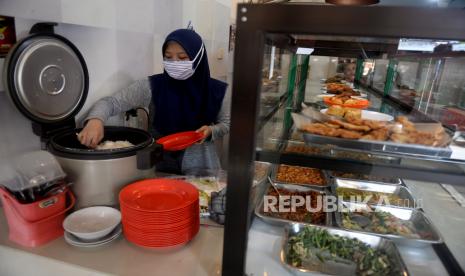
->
[304,133,452,157]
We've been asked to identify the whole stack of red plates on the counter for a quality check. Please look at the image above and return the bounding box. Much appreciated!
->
[119,179,200,248]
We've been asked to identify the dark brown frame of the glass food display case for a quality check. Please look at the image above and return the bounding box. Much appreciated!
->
[222,4,465,275]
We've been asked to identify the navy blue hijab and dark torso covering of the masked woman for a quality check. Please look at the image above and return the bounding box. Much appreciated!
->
[149,29,227,136]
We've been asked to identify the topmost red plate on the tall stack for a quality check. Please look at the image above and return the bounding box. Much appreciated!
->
[119,179,199,212]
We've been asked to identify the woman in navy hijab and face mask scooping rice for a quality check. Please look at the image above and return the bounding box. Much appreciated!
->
[78,29,230,174]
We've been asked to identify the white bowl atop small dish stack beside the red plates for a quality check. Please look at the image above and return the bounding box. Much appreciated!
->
[63,206,121,240]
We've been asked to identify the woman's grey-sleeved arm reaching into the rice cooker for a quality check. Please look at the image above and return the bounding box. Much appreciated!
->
[84,79,152,122]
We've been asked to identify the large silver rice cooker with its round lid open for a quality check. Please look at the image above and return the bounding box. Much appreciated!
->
[4,23,162,208]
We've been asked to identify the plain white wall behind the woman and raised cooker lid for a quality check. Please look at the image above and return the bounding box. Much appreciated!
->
[0,0,230,161]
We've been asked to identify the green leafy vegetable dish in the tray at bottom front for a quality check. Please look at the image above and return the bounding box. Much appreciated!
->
[286,227,401,275]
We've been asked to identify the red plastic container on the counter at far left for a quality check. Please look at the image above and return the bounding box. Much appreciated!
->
[0,188,76,247]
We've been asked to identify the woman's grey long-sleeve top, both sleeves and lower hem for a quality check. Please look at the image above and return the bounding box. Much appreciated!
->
[85,79,231,174]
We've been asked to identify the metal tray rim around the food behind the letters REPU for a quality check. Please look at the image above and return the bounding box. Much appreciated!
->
[255,184,333,227]
